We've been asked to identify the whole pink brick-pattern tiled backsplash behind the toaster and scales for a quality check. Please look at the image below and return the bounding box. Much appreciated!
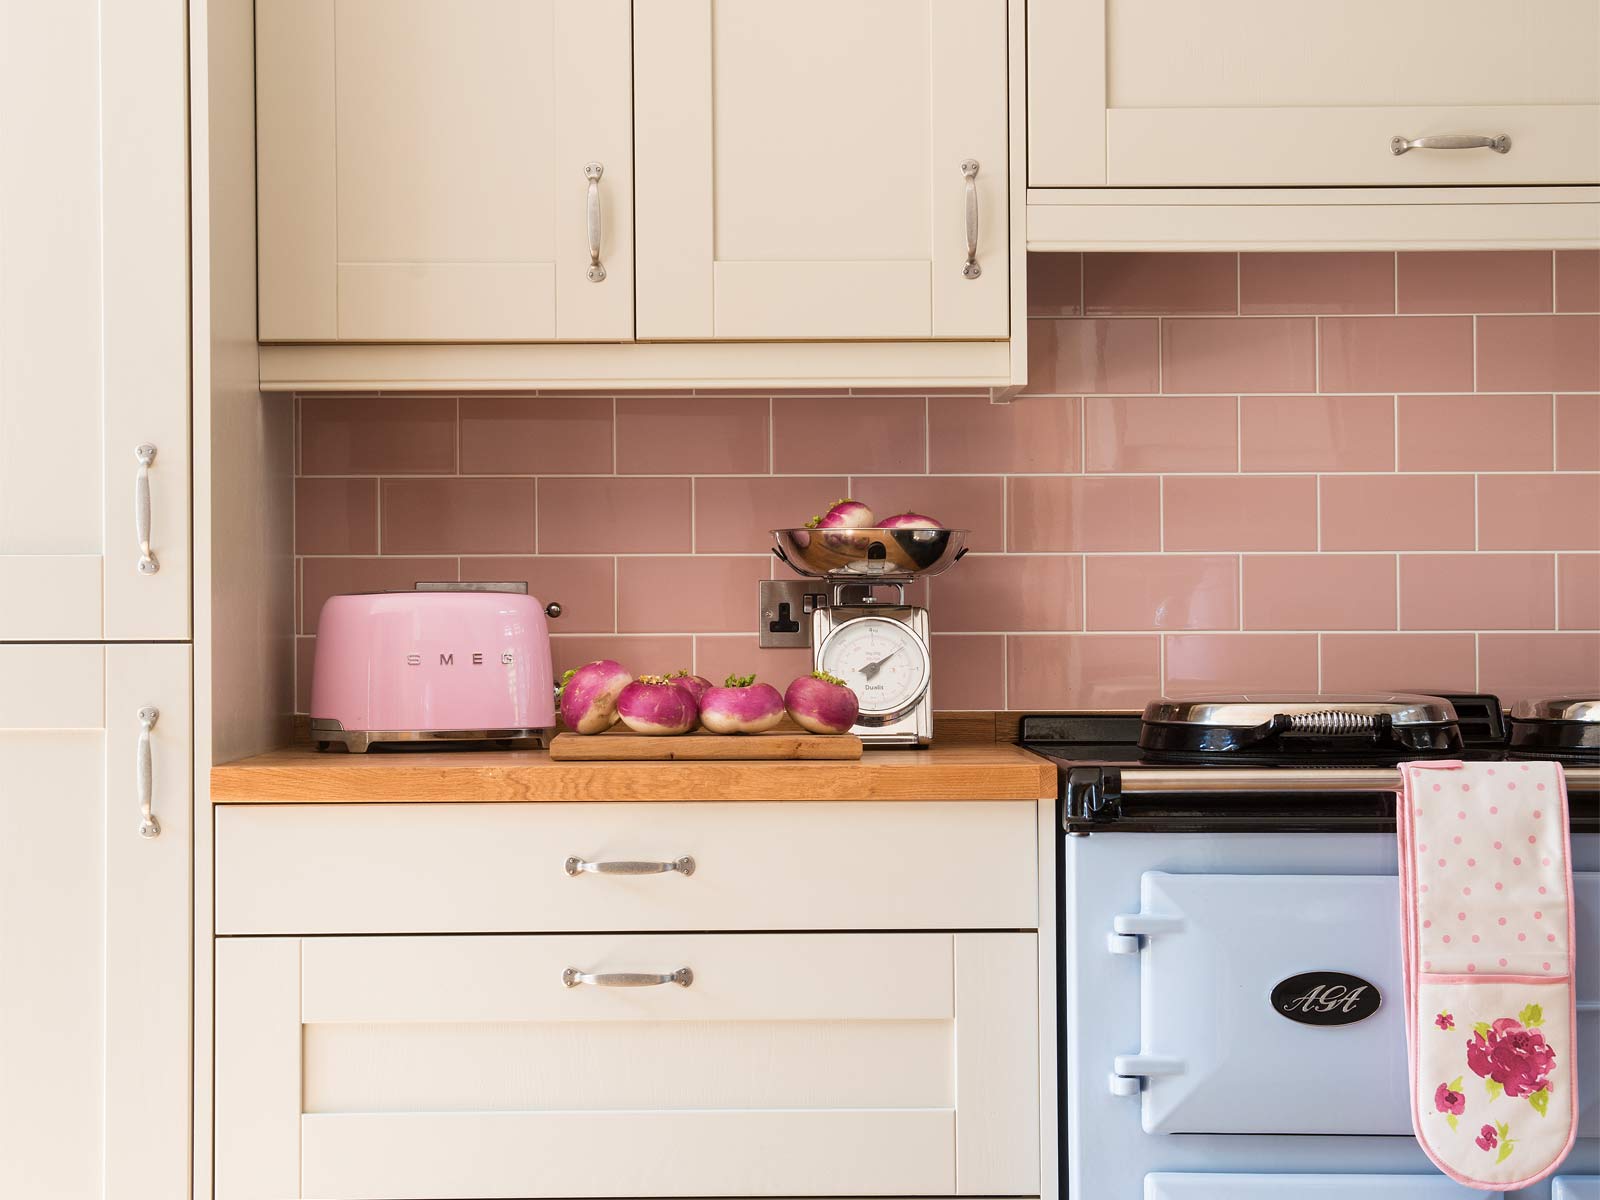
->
[294,251,1600,709]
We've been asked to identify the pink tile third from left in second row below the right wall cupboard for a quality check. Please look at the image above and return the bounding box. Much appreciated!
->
[1318,317,1465,392]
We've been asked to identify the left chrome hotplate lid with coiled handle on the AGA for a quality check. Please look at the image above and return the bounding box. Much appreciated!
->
[1139,693,1464,766]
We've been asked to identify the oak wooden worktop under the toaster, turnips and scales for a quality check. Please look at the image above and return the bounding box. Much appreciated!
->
[211,744,1056,805]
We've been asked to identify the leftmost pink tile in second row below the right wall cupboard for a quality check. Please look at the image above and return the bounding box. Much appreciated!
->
[1026,318,1162,395]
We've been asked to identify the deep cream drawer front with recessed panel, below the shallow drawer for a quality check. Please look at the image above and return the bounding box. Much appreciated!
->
[216,933,1038,1200]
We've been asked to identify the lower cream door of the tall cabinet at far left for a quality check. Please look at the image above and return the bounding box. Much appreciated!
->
[0,645,194,1200]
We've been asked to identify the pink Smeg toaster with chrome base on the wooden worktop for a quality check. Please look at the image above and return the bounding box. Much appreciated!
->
[310,582,560,752]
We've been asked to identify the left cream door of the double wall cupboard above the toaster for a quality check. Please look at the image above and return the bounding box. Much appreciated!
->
[256,0,634,342]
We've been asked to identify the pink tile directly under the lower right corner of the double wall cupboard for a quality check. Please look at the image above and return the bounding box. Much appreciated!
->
[928,395,1083,474]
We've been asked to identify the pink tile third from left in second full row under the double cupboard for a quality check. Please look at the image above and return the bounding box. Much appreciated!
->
[539,477,691,554]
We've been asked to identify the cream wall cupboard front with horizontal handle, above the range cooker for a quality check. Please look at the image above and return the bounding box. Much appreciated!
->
[1029,0,1600,187]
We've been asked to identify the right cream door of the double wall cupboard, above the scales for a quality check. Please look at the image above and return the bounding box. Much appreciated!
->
[634,0,1008,339]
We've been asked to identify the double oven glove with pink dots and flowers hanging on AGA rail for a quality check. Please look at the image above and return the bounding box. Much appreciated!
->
[1397,762,1578,1190]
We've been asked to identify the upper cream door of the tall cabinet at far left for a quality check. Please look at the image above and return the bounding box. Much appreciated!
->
[0,0,189,642]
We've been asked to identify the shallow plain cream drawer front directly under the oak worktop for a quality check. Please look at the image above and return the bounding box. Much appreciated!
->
[216,802,1038,934]
